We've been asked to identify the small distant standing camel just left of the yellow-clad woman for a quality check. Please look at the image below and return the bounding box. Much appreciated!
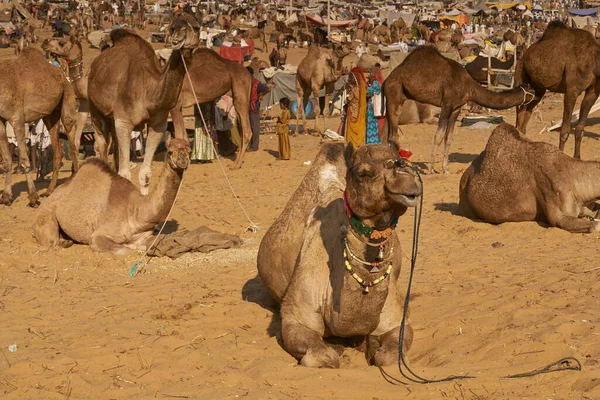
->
[296,44,350,132]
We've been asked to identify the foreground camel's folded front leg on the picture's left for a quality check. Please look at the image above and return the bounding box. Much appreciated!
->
[281,313,340,368]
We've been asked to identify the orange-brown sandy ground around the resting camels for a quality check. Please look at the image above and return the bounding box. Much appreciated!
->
[0,25,600,400]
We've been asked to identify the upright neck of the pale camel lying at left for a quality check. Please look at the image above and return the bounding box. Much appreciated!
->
[138,160,183,225]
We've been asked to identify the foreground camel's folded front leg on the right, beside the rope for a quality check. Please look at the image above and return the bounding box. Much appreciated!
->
[367,322,413,367]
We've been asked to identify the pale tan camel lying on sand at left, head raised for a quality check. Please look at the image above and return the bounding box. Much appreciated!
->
[33,139,190,250]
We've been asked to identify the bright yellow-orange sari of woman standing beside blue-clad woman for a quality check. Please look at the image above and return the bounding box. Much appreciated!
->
[346,74,367,148]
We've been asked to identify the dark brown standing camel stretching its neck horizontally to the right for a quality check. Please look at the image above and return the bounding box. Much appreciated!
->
[383,46,533,173]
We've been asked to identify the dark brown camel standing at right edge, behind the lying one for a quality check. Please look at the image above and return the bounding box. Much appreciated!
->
[515,21,600,158]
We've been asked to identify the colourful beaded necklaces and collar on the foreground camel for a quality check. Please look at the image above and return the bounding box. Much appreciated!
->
[344,192,398,294]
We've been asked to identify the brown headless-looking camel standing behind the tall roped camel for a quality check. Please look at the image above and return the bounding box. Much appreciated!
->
[171,48,252,168]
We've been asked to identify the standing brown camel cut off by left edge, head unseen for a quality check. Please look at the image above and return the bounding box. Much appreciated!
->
[0,47,78,207]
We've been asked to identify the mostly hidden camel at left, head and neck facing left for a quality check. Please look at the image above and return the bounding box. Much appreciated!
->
[42,36,90,172]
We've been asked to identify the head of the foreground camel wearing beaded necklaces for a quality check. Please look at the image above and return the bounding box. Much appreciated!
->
[345,143,422,229]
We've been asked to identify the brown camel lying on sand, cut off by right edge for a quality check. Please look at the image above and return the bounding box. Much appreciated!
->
[458,124,600,233]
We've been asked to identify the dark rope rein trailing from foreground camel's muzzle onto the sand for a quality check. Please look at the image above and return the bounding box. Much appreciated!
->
[379,167,581,385]
